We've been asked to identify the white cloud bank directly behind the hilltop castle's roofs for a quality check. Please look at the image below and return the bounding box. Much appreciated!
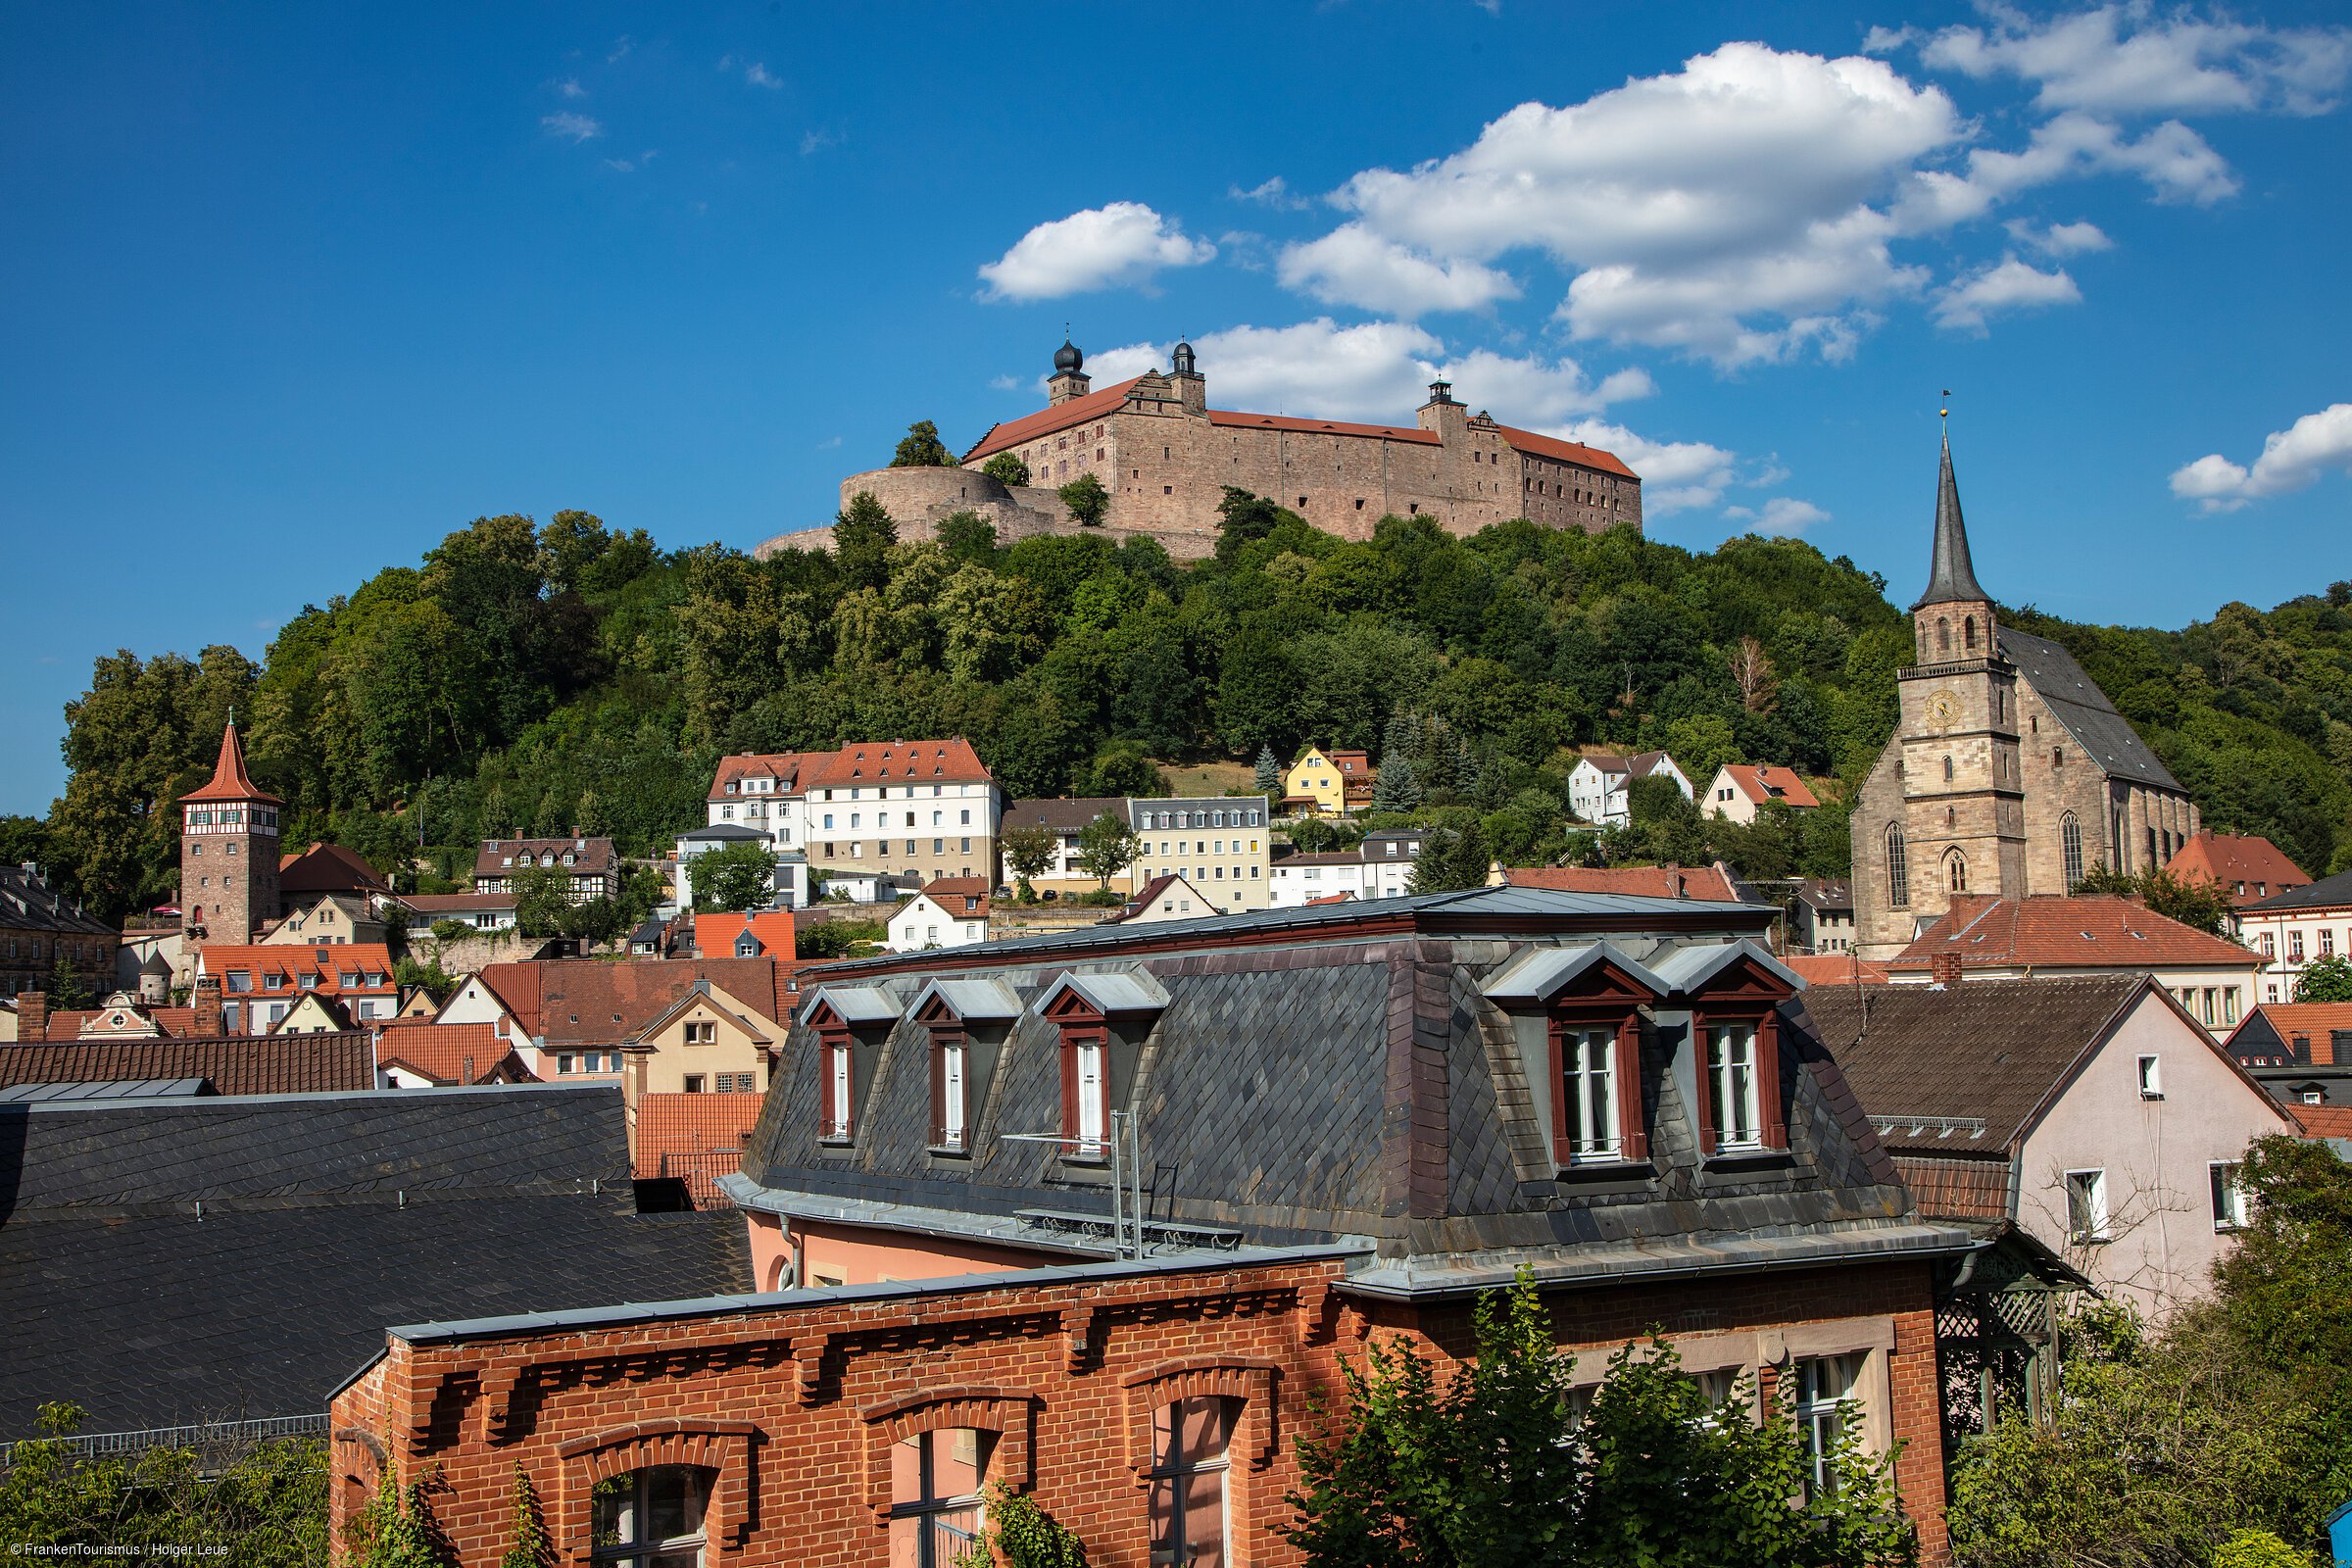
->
[1037,318,1656,425]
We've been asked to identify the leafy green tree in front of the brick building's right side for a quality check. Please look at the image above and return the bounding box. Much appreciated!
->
[1287,1272,1919,1568]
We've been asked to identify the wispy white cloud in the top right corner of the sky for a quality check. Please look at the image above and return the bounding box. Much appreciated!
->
[1909,0,2352,116]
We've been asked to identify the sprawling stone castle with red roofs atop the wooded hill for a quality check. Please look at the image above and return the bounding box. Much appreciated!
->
[758,343,1642,560]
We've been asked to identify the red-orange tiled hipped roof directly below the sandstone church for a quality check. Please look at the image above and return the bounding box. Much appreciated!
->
[1886,894,2260,971]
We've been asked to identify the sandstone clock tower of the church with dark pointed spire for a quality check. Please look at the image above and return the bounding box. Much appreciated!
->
[1884,430,2025,924]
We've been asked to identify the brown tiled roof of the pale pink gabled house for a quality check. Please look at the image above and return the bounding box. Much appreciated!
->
[1789,973,2154,1154]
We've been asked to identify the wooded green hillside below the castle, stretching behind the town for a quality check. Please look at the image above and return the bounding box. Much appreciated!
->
[18,491,2352,917]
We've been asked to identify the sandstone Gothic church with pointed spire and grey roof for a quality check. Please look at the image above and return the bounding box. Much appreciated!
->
[1853,435,2199,959]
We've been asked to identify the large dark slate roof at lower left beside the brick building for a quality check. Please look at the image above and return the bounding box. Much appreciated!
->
[0,1086,751,1439]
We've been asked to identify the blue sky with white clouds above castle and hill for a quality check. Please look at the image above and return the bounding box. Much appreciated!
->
[0,0,2352,813]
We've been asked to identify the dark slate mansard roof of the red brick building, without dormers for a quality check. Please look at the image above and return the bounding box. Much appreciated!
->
[729,889,1950,1291]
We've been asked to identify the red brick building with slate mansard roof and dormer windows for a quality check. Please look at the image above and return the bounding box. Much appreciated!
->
[334,889,1978,1568]
